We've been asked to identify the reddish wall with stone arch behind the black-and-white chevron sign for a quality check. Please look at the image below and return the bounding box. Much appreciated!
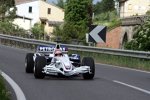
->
[97,26,136,49]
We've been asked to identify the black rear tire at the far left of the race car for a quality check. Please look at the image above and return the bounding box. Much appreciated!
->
[25,53,34,73]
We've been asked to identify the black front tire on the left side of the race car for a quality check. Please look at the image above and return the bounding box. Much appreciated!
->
[34,56,46,79]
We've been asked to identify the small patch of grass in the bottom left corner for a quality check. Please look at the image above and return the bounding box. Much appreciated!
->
[0,75,10,100]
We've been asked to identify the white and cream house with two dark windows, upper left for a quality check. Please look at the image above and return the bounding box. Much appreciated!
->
[14,0,64,35]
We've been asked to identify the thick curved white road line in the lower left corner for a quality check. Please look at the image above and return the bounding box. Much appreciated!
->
[0,71,26,100]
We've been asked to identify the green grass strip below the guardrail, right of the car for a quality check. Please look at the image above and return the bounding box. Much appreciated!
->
[69,51,150,71]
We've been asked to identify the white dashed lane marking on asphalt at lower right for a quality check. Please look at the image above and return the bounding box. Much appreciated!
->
[113,80,150,95]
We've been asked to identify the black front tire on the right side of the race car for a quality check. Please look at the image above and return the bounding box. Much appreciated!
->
[82,57,95,80]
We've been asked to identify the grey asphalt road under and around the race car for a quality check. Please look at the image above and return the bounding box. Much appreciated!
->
[0,45,150,100]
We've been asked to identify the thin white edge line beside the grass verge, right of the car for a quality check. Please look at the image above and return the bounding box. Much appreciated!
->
[96,63,150,74]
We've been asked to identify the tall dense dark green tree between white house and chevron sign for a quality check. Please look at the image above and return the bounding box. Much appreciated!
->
[64,0,92,40]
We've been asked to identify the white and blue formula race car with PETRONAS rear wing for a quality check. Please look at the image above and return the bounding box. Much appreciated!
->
[25,44,95,79]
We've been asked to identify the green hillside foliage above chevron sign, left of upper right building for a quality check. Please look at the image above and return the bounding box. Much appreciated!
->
[93,0,121,30]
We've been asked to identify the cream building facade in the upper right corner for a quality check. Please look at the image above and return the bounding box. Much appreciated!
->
[119,0,150,18]
